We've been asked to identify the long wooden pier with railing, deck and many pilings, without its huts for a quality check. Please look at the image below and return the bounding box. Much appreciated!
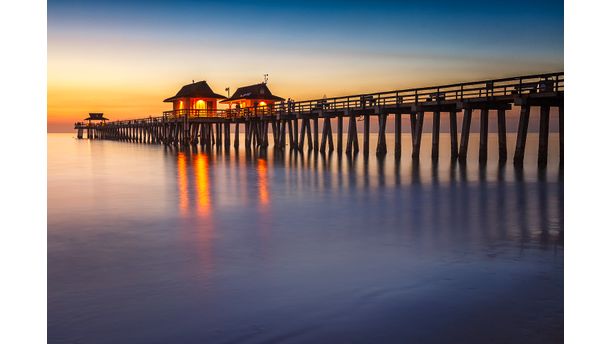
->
[75,72,563,167]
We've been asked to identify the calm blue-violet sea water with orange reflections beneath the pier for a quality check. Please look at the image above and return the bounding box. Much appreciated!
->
[48,134,563,343]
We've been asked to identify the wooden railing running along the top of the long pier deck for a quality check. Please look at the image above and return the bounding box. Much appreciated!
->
[77,72,564,125]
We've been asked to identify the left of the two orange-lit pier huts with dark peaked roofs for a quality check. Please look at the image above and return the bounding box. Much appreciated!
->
[164,81,227,115]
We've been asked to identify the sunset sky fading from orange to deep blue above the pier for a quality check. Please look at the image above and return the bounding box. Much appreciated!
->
[47,0,563,132]
